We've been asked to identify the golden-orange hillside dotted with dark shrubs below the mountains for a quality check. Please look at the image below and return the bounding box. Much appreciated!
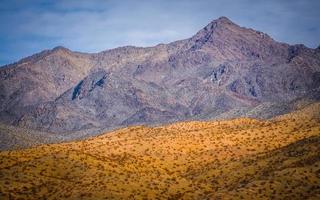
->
[0,103,320,199]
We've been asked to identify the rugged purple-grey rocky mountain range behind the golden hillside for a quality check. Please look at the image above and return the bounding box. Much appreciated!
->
[0,17,320,133]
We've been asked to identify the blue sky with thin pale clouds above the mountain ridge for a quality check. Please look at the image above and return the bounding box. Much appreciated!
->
[0,0,320,65]
